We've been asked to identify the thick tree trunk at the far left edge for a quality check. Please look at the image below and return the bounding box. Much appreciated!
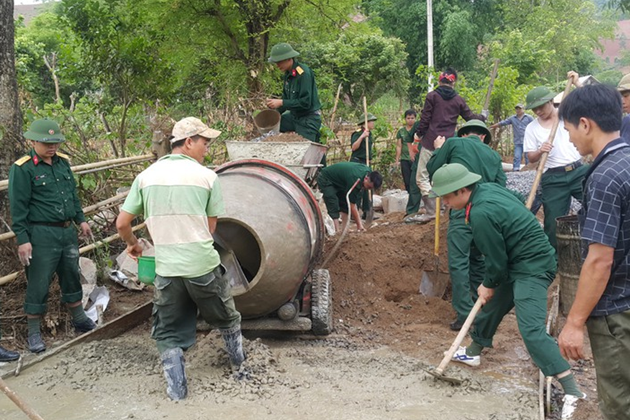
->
[0,0,26,226]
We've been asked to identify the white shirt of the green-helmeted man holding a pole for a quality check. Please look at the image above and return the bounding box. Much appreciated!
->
[523,118,580,171]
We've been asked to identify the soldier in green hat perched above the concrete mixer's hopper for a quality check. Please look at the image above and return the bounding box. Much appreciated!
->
[267,42,322,143]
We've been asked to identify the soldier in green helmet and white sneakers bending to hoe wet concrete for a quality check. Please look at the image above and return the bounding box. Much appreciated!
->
[433,163,584,419]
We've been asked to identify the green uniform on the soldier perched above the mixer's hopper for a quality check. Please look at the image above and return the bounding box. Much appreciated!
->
[278,59,322,143]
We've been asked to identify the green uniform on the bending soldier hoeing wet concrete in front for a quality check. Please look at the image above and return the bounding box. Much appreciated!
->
[466,183,570,376]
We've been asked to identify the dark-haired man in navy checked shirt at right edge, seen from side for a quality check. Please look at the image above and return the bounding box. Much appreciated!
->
[558,85,630,420]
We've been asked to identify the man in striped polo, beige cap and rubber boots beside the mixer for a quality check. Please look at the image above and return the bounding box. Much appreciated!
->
[116,117,246,400]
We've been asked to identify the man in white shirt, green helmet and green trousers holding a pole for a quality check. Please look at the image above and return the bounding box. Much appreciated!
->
[524,86,588,248]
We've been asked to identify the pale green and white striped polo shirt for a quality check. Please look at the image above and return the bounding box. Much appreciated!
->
[122,154,224,278]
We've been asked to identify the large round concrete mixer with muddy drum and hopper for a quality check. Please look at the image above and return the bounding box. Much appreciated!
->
[215,141,332,335]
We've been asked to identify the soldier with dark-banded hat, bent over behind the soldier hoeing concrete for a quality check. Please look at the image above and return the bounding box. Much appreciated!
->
[427,119,507,331]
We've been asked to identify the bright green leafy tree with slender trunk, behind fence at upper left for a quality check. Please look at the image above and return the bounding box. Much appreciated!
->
[61,0,175,156]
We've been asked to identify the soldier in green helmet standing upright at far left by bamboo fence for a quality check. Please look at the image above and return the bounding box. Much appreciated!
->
[9,119,96,353]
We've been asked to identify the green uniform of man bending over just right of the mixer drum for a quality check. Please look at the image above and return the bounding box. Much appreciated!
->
[317,162,371,219]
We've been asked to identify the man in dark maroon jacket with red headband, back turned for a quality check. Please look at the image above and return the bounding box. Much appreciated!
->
[405,68,488,223]
